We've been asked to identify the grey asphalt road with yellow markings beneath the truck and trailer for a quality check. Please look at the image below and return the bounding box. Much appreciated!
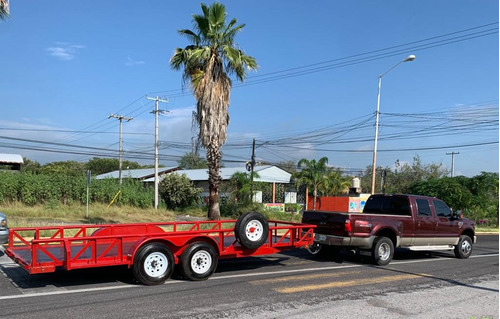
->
[0,235,499,319]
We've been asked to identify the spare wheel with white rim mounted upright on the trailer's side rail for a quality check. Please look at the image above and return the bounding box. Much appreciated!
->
[234,212,269,249]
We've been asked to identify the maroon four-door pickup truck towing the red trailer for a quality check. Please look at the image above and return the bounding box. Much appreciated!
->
[302,194,476,266]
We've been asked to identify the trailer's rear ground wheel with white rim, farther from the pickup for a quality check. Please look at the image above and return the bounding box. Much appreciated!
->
[133,243,174,285]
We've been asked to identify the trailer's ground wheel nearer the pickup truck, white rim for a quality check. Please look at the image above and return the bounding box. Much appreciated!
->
[181,241,218,281]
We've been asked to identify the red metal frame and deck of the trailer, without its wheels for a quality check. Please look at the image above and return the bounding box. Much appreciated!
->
[5,220,315,280]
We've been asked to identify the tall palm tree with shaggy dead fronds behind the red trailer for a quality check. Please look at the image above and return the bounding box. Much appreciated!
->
[170,2,257,219]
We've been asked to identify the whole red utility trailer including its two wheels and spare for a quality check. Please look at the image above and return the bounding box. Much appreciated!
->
[5,212,316,285]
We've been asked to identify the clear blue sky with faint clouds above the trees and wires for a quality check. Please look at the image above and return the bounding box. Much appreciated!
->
[0,0,499,176]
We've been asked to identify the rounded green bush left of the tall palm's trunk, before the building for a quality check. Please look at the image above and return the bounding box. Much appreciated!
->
[159,173,202,209]
